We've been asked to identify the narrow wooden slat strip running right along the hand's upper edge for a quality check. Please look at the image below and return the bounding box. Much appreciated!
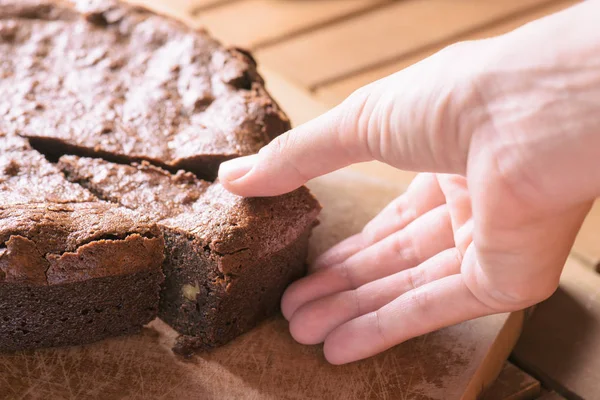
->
[316,0,580,105]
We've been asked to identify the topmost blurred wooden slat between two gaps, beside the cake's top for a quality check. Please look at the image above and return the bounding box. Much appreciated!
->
[195,0,390,48]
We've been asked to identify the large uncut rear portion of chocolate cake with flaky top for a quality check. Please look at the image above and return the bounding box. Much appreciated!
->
[0,0,290,179]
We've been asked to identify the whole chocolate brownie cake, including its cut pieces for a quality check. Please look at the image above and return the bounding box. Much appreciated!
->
[0,0,320,355]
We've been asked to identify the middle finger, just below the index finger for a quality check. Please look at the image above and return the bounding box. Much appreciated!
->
[281,206,453,320]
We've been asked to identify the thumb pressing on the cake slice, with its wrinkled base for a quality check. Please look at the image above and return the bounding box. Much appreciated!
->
[219,42,485,196]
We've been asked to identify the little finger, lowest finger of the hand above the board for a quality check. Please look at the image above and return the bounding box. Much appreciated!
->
[323,274,496,364]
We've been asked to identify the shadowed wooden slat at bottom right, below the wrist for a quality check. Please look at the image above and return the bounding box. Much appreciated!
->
[513,258,600,399]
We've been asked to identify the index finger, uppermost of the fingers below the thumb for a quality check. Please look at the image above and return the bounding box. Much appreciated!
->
[310,173,444,272]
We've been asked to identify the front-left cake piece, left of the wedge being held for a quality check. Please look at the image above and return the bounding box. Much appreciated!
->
[0,136,164,351]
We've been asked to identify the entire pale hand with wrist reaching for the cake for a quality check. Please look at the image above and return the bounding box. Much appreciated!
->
[219,1,600,364]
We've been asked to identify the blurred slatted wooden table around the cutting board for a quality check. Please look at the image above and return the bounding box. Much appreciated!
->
[137,0,600,400]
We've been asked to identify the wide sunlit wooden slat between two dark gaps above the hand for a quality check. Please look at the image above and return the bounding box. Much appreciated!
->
[257,0,549,89]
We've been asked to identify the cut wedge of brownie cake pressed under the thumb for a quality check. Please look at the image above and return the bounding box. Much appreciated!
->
[59,156,320,353]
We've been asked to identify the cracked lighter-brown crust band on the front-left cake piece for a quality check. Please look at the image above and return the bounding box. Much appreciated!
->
[0,202,162,286]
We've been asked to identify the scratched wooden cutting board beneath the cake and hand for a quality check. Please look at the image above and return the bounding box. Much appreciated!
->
[0,171,523,400]
